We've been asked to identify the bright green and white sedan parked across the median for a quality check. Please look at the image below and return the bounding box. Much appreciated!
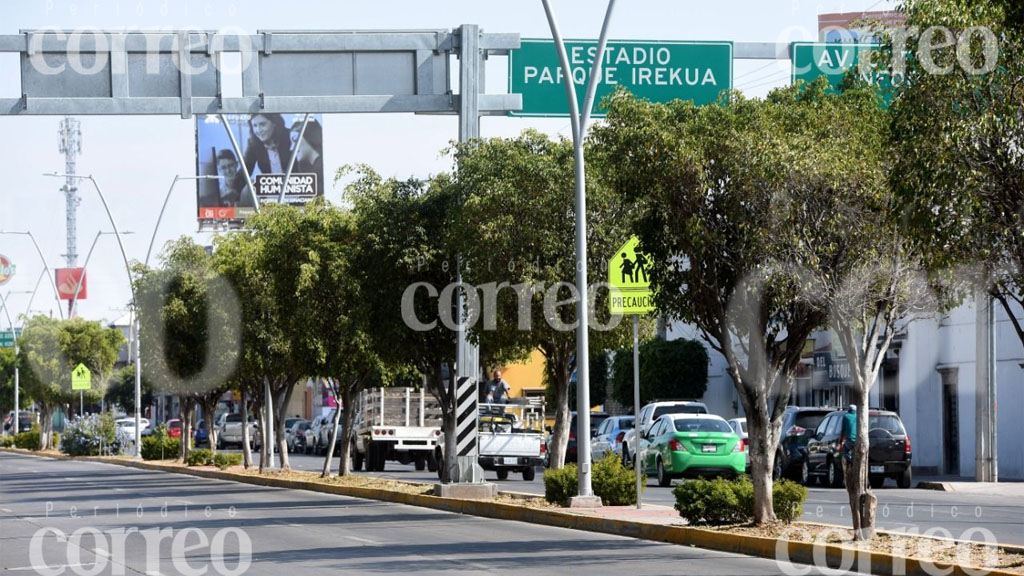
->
[643,414,746,486]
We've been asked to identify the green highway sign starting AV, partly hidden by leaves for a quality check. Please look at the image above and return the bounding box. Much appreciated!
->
[792,42,893,106]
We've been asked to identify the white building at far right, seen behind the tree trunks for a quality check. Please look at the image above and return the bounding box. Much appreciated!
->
[668,293,1024,480]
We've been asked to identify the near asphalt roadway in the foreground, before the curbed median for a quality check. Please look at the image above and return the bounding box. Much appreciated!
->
[0,454,847,576]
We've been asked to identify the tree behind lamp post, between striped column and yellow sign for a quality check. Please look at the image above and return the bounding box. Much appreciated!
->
[453,131,629,468]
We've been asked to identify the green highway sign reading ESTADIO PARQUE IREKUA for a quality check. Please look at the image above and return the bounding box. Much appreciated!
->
[509,40,732,117]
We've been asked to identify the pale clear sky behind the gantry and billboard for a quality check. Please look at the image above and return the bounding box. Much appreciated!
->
[0,0,894,328]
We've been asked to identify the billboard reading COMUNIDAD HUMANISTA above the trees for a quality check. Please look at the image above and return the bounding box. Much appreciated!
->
[196,113,325,220]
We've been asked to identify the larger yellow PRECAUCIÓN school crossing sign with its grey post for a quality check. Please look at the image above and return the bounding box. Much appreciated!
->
[608,236,654,509]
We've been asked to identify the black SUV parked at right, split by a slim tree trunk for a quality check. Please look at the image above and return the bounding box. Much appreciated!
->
[801,410,912,488]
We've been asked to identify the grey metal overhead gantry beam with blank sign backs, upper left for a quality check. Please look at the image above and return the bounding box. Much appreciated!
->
[0,29,521,118]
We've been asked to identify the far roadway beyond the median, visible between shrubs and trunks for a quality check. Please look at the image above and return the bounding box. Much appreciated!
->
[274,454,1024,545]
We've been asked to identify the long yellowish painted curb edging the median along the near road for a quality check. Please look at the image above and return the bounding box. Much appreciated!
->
[0,448,1021,576]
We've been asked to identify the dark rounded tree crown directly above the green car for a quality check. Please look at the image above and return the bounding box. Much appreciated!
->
[611,338,709,406]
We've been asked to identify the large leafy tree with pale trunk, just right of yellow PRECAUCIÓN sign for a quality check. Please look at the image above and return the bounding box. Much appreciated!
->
[593,87,857,524]
